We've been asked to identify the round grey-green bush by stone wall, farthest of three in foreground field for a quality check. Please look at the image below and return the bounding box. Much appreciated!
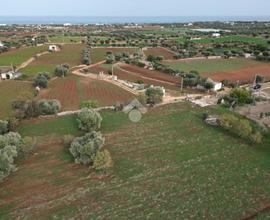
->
[77,108,102,132]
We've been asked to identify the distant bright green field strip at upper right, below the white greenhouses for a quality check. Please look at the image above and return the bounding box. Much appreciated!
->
[193,35,267,45]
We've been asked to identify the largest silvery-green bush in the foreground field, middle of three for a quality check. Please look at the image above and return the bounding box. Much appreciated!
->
[69,131,105,165]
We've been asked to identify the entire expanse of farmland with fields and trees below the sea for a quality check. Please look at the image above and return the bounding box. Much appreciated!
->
[0,13,270,219]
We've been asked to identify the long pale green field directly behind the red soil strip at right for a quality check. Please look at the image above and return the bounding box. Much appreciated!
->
[163,59,259,73]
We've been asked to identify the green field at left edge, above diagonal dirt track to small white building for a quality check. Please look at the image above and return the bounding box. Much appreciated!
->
[0,45,48,66]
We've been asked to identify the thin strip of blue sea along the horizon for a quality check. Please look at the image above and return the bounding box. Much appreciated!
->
[0,16,270,25]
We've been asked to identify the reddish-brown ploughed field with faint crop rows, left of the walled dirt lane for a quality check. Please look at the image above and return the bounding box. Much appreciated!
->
[39,76,133,111]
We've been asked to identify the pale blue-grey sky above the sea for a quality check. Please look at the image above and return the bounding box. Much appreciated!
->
[0,0,270,16]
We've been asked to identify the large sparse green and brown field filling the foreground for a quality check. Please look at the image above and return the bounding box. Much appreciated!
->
[0,103,270,220]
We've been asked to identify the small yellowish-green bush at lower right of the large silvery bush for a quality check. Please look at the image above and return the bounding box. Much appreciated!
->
[93,150,113,171]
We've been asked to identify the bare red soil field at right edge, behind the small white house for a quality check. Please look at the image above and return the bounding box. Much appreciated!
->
[202,63,270,84]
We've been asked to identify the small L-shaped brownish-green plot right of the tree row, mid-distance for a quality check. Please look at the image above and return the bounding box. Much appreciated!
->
[91,47,138,64]
